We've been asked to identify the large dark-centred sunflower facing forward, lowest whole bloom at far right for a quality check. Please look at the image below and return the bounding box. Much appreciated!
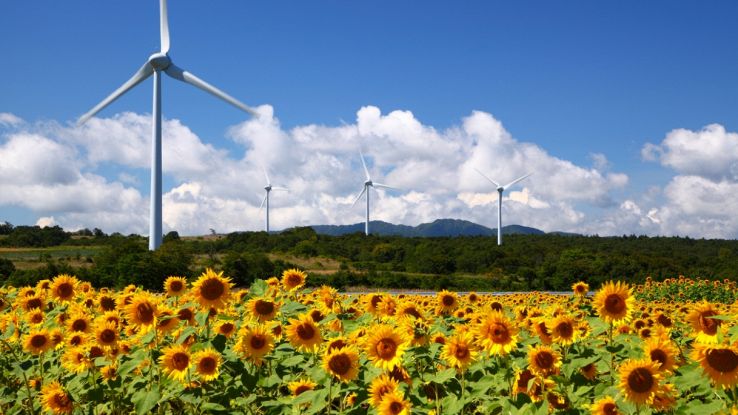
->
[620,359,662,405]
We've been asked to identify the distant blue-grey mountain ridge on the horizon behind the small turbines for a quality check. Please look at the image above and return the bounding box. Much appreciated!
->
[311,219,545,237]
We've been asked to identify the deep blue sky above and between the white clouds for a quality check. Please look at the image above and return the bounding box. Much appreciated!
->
[0,1,738,237]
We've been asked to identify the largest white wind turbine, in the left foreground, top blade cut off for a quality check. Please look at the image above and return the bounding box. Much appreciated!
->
[77,0,258,251]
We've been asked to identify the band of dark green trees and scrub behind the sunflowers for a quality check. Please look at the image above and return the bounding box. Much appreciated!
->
[0,222,738,291]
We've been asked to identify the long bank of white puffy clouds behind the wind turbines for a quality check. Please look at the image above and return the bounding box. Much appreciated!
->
[0,106,628,234]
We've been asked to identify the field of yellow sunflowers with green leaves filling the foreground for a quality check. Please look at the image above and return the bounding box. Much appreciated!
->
[0,269,738,415]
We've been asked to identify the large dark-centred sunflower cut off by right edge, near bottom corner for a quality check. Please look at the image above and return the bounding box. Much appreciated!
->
[692,342,738,388]
